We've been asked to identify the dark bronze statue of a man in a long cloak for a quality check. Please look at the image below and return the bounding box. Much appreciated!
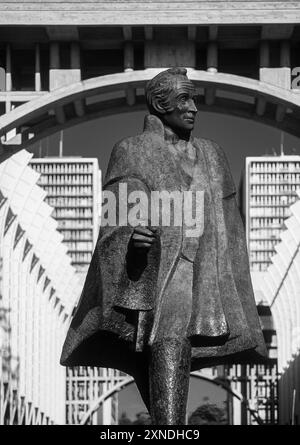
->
[61,68,265,425]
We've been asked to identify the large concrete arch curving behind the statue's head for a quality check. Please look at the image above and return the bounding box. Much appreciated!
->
[0,68,300,161]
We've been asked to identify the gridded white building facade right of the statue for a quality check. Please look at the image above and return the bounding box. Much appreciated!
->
[245,156,300,272]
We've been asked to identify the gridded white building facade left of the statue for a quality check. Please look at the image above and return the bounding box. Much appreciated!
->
[30,157,101,284]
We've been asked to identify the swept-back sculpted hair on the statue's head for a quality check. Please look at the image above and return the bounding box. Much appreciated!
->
[146,67,187,114]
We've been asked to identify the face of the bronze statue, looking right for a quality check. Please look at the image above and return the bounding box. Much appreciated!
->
[163,78,198,132]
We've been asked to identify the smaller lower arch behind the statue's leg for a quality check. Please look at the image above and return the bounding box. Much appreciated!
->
[80,371,263,425]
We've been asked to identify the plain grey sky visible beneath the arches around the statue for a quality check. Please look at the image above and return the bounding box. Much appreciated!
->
[29,111,300,419]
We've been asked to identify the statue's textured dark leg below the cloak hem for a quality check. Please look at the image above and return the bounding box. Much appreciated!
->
[149,339,191,425]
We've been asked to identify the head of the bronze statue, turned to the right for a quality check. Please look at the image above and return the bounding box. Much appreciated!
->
[146,68,197,133]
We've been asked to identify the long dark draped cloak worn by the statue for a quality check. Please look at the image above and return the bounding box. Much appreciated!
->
[61,115,266,375]
